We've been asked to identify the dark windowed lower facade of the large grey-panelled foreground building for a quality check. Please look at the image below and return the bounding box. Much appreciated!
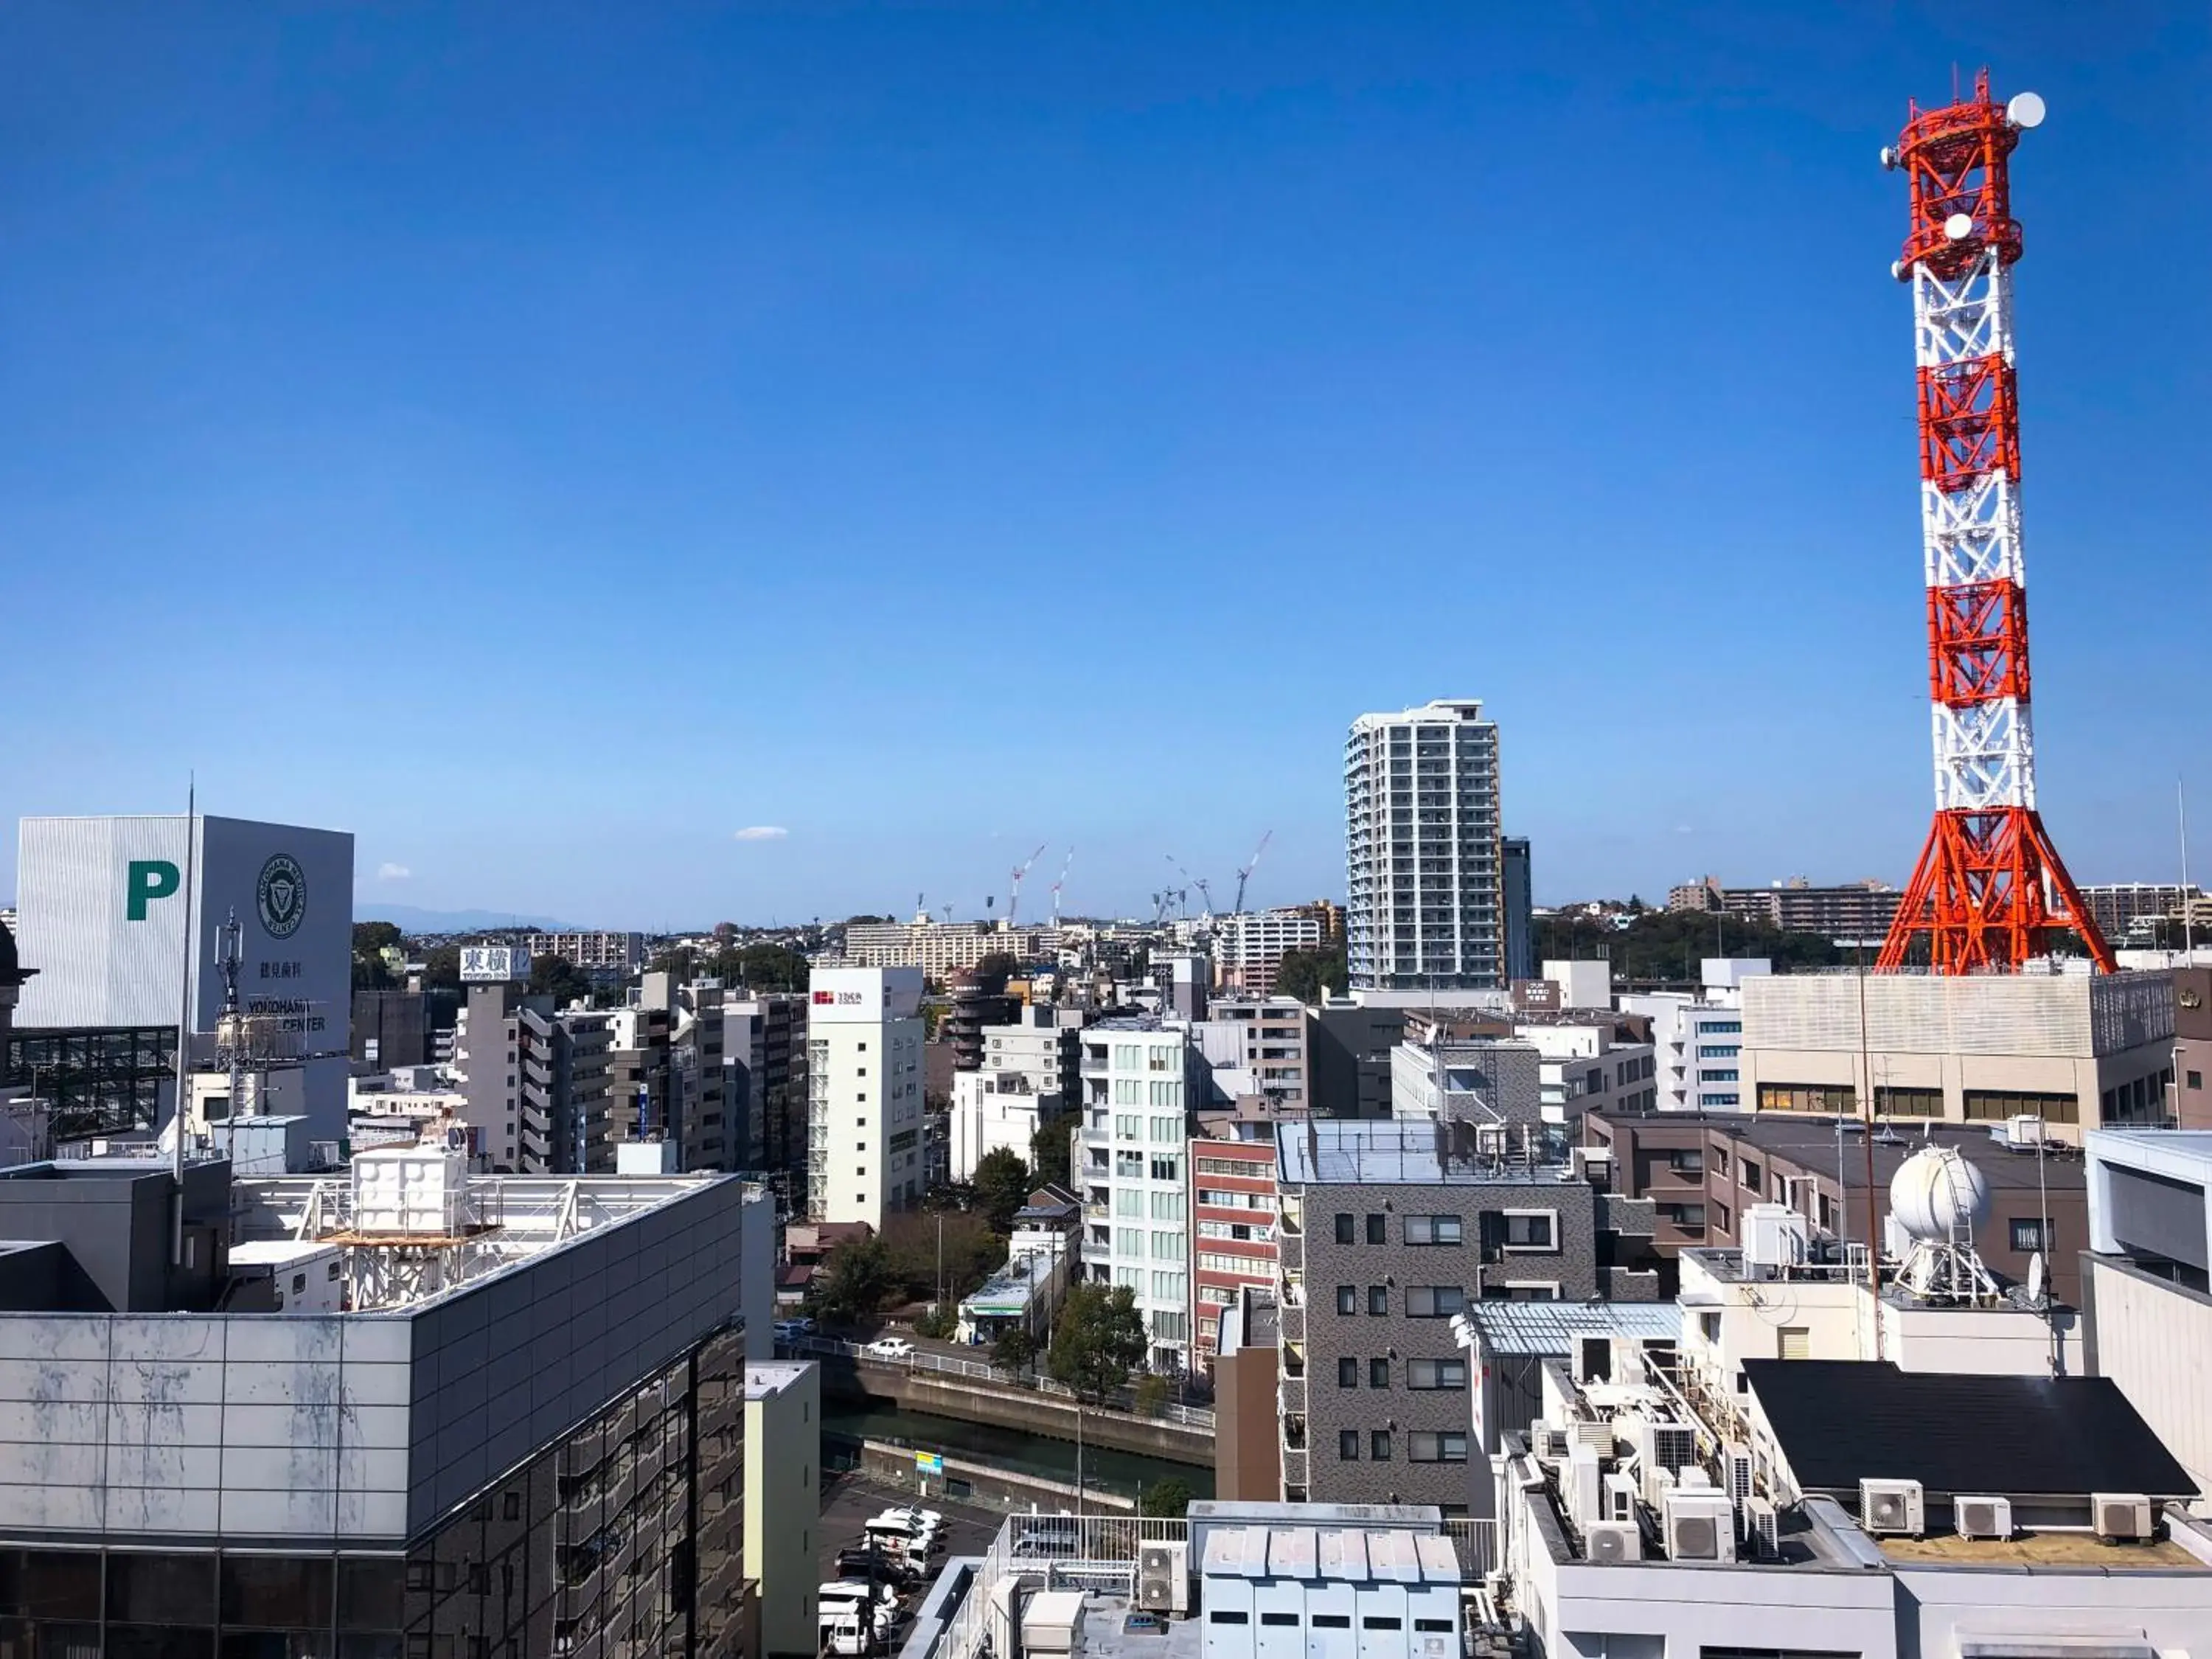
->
[0,1327,752,1659]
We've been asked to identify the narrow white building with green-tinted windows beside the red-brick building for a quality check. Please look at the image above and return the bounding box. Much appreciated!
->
[1075,1015,1206,1371]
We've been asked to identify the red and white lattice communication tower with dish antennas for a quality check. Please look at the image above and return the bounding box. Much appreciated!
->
[1876,69,2115,973]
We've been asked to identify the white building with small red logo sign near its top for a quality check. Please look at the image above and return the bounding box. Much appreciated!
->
[807,967,927,1232]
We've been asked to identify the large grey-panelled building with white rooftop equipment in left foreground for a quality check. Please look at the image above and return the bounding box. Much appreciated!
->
[0,1148,774,1659]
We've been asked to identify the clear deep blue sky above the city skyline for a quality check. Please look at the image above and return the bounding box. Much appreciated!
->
[0,0,2212,927]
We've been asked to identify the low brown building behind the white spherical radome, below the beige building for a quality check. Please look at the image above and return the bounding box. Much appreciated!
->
[1582,1113,2088,1305]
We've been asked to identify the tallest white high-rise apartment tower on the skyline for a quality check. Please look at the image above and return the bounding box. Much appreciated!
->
[1345,699,1506,991]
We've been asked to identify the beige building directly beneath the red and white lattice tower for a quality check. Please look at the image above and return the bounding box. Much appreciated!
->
[1736,973,2174,1141]
